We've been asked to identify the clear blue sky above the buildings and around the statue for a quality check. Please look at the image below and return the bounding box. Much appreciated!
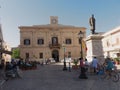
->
[0,0,120,47]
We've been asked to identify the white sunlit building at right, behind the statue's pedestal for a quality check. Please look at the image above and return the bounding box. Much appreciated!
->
[102,27,120,58]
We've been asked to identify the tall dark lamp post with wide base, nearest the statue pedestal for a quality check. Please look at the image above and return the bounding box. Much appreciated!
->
[78,31,87,79]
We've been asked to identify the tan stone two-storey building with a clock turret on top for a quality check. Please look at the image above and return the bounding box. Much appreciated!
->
[19,16,86,61]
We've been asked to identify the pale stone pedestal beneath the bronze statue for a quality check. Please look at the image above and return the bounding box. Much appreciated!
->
[86,34,104,63]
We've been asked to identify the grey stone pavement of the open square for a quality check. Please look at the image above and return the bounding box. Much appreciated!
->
[1,65,120,90]
